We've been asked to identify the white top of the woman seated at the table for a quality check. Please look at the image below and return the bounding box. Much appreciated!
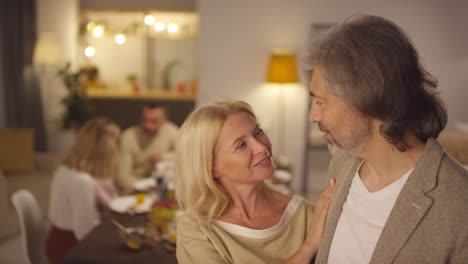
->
[49,165,100,240]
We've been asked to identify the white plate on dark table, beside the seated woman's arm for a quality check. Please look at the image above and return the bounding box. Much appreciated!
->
[109,195,155,214]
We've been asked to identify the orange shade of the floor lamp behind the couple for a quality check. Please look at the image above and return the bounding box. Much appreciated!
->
[267,51,298,83]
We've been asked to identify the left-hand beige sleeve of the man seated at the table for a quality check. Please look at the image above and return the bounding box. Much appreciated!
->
[117,134,137,193]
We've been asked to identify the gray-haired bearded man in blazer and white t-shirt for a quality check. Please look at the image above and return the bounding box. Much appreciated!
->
[301,15,468,264]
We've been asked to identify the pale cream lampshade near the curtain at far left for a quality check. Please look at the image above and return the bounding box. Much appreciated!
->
[33,32,61,65]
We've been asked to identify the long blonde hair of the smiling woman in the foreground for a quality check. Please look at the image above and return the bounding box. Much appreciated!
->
[176,101,256,224]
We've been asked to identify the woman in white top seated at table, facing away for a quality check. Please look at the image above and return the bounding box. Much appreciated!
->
[47,117,120,263]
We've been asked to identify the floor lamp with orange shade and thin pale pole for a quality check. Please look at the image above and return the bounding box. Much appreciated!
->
[267,49,298,166]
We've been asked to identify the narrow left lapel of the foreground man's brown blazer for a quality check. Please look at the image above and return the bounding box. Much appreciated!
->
[315,156,361,263]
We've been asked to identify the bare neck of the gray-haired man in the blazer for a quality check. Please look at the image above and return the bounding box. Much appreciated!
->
[359,133,425,192]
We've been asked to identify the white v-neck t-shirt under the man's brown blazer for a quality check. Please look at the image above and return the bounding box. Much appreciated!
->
[328,164,413,264]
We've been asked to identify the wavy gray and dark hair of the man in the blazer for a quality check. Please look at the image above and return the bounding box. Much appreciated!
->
[300,15,447,151]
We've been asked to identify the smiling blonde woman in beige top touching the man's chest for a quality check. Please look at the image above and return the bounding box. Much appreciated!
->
[176,101,334,263]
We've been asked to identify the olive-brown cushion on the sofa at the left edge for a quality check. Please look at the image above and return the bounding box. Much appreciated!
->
[0,128,35,173]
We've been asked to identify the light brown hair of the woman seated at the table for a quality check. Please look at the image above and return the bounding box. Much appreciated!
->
[63,117,120,178]
